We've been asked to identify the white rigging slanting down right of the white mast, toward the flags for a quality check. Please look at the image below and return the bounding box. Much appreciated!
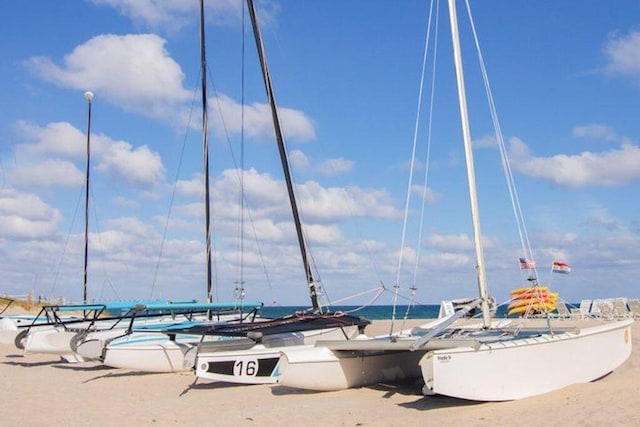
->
[465,0,537,278]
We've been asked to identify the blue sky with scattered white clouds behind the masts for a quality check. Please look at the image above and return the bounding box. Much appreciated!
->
[0,0,640,305]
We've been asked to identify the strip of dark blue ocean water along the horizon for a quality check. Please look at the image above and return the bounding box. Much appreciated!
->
[260,304,506,320]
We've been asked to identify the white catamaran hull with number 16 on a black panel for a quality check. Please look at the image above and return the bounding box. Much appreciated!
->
[195,326,358,384]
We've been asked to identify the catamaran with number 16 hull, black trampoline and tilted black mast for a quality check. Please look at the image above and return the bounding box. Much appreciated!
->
[159,0,370,384]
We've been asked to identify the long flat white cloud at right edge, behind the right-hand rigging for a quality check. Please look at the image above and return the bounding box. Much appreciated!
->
[510,138,640,187]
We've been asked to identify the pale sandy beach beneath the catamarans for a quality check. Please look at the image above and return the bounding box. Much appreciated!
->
[0,320,640,426]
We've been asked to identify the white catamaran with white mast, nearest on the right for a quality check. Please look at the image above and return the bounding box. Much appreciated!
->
[279,0,633,401]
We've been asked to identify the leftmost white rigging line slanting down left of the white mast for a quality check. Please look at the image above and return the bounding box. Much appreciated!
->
[389,2,433,334]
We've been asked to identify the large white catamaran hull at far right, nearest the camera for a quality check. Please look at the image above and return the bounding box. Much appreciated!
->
[420,319,633,401]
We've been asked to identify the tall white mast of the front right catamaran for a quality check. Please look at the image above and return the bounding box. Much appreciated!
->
[449,0,491,328]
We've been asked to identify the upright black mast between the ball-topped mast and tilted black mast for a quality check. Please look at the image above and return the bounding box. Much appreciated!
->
[200,0,213,302]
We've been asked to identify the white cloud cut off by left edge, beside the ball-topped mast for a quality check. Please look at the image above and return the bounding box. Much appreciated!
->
[0,189,62,240]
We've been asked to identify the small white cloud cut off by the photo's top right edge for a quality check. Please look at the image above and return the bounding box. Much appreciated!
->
[604,31,640,84]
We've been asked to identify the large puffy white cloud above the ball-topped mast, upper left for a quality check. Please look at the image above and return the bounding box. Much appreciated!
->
[25,34,191,119]
